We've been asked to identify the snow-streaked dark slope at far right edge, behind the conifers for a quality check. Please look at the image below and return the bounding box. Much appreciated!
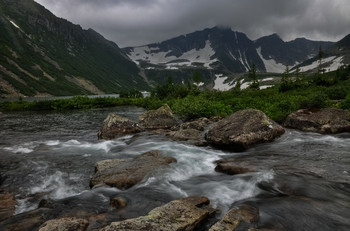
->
[294,34,350,72]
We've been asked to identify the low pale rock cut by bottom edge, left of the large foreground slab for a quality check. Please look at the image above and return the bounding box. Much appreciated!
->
[39,217,89,231]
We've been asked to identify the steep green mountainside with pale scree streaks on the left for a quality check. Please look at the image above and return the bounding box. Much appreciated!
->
[0,0,149,97]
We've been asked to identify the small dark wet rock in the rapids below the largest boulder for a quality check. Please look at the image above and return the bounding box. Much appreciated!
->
[215,159,257,175]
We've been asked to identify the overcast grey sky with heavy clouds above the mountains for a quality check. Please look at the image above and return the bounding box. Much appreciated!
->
[35,0,350,47]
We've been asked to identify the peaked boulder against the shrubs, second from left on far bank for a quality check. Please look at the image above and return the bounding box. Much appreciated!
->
[139,105,178,129]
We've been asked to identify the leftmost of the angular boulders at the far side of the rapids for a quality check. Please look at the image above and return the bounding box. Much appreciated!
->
[97,113,143,139]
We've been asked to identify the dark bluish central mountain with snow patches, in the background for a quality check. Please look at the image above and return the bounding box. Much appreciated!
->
[123,27,333,75]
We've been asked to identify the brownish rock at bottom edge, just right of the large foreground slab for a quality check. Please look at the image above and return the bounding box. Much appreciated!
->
[209,204,259,231]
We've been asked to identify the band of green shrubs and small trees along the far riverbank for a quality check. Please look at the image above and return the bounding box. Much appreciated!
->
[0,66,350,122]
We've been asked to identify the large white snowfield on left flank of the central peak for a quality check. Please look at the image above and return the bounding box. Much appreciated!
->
[128,40,218,69]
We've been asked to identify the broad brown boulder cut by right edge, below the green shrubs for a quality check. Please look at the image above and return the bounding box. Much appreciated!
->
[283,108,350,134]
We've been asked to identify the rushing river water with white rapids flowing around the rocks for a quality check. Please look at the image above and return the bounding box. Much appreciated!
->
[0,107,350,230]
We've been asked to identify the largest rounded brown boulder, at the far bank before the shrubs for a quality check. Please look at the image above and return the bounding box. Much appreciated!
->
[205,109,285,151]
